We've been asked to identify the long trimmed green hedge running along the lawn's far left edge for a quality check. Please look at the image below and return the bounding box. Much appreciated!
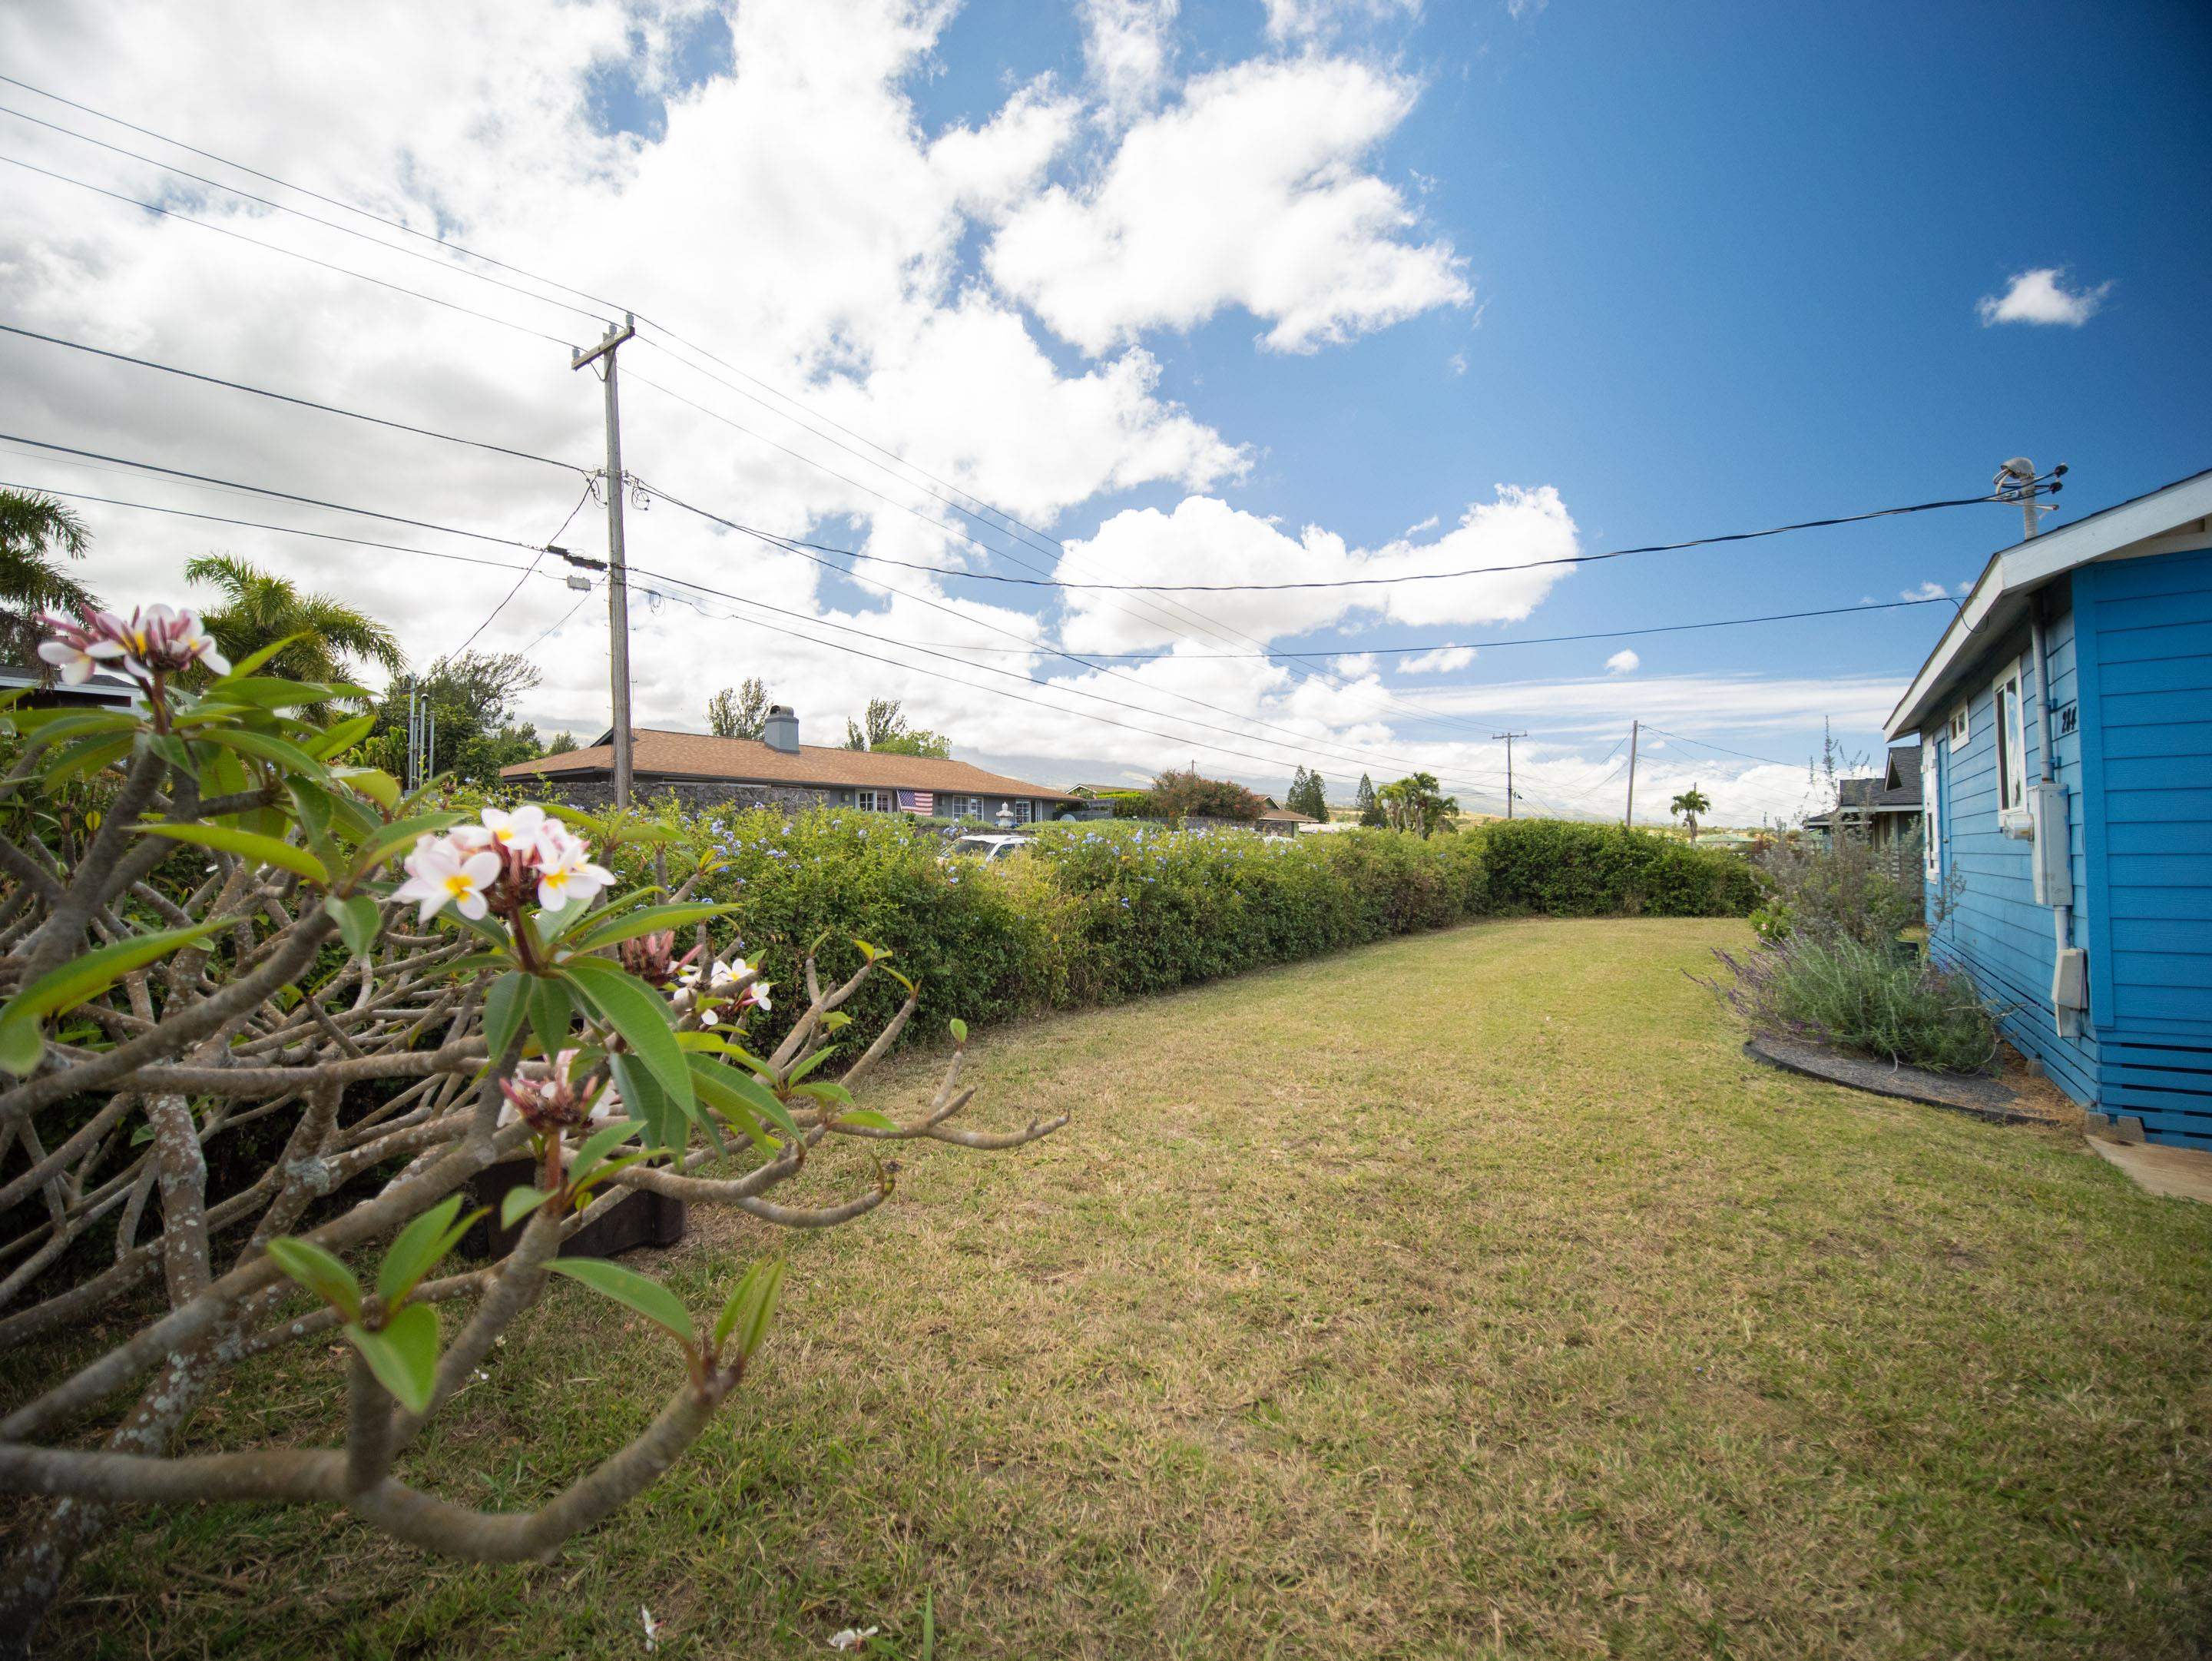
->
[614,810,1757,1053]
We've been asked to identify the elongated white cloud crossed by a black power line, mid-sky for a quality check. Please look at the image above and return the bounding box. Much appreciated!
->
[1058,484,1575,652]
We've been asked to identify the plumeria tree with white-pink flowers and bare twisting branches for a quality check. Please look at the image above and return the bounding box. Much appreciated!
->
[0,606,1064,1648]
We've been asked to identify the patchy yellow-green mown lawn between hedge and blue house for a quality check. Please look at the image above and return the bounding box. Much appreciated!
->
[17,920,2212,1661]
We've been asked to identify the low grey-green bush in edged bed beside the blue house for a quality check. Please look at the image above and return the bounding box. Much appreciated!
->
[1714,933,1998,1073]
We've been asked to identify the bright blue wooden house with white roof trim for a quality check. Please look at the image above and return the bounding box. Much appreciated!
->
[1889,471,2212,1148]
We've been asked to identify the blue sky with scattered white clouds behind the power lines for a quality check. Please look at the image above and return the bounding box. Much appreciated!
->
[0,0,2212,821]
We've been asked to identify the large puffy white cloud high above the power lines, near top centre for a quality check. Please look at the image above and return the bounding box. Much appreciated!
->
[986,55,1473,354]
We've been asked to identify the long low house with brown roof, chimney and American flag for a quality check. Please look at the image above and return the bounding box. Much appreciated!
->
[500,703,1075,825]
